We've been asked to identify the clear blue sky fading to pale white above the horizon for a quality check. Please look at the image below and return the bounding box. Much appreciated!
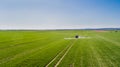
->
[0,0,120,29]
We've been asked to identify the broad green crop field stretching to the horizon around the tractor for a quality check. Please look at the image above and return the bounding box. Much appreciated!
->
[0,30,120,67]
